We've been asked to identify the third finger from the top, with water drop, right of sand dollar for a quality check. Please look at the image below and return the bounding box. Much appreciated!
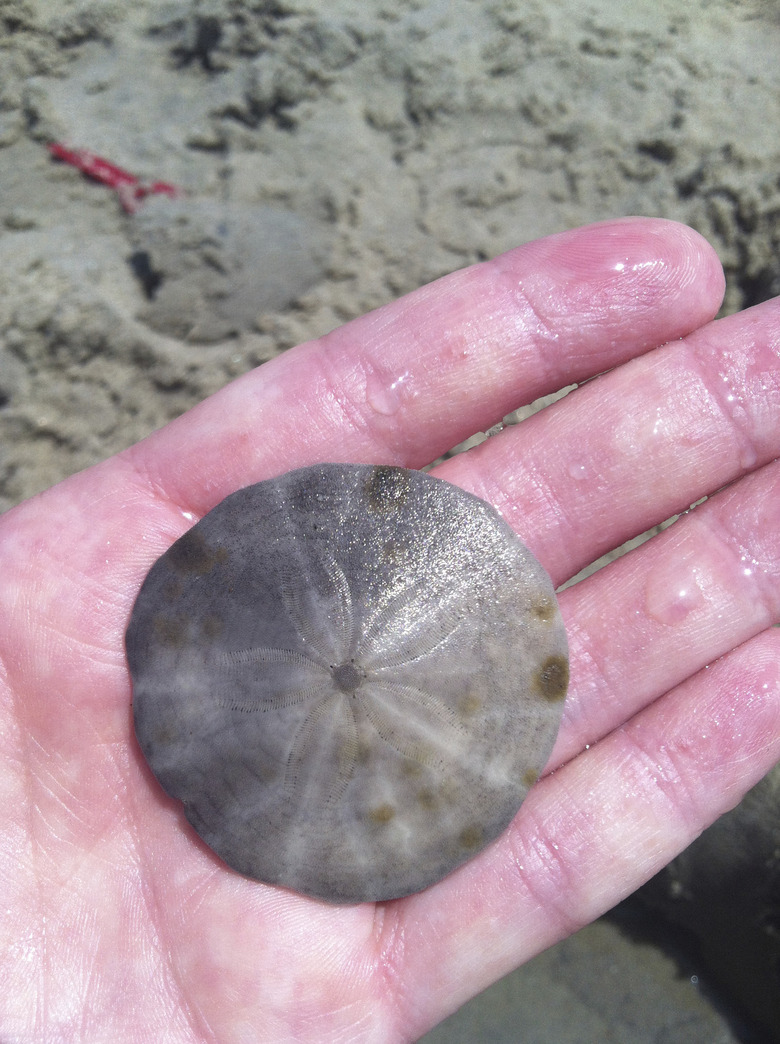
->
[550,460,780,765]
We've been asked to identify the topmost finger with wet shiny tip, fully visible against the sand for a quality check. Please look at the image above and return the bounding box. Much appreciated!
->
[126,218,723,515]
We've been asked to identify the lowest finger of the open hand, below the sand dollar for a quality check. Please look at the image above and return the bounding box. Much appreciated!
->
[392,630,780,1034]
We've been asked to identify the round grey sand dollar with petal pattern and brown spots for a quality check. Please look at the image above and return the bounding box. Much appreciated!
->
[126,464,568,903]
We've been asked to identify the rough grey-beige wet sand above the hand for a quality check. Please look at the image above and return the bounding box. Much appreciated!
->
[0,0,780,508]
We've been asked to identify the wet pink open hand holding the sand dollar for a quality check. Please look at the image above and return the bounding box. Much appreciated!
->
[0,219,780,1044]
